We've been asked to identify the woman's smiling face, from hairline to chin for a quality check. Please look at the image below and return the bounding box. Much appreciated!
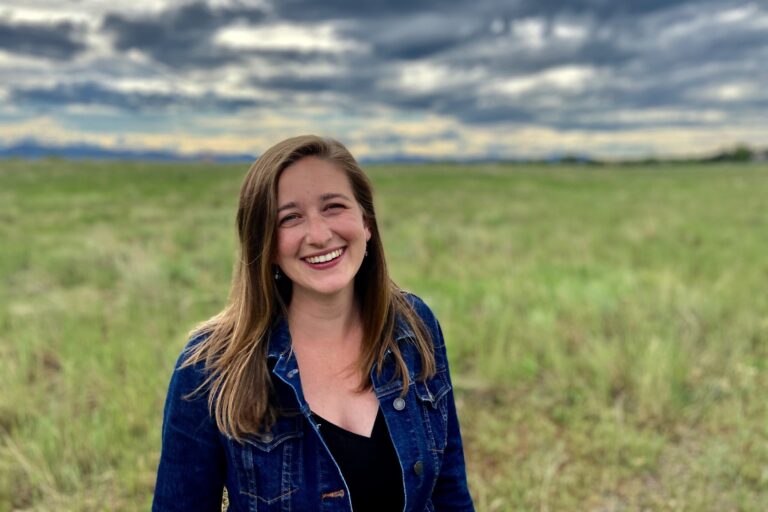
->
[275,156,371,297]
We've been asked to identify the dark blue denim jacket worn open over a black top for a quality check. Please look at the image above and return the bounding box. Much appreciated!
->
[152,296,474,512]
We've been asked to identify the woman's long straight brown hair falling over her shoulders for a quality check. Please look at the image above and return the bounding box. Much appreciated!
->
[178,135,435,440]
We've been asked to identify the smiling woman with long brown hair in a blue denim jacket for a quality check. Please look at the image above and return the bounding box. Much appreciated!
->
[153,136,473,512]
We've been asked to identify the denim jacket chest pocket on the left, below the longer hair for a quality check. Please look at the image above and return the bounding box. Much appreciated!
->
[232,416,303,512]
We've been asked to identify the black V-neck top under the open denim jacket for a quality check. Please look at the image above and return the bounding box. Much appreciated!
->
[313,409,405,512]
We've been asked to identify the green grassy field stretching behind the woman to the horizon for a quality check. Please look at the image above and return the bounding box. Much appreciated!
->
[0,161,768,512]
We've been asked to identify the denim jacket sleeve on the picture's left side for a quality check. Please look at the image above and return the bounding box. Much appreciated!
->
[152,340,226,512]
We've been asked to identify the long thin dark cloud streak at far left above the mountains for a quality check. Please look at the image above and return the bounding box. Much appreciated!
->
[10,82,259,112]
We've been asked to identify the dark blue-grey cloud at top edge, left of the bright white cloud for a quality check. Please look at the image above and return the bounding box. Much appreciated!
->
[103,2,263,68]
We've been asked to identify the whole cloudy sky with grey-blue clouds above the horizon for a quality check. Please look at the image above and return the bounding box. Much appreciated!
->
[0,0,768,158]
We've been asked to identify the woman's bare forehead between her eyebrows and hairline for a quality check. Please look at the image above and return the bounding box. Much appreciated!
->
[277,156,353,203]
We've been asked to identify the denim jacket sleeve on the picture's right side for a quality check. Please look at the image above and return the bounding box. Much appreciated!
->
[417,303,475,512]
